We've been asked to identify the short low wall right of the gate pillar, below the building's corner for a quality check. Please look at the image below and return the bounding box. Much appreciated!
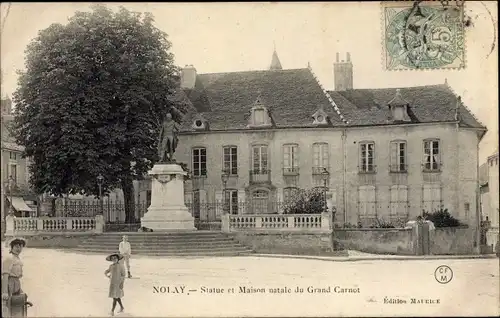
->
[430,227,477,255]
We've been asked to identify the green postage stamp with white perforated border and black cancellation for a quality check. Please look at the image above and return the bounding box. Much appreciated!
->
[381,1,466,70]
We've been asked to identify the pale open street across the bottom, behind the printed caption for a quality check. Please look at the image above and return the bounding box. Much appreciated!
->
[4,248,499,317]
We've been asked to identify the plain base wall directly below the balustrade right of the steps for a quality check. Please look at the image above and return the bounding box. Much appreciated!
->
[230,231,347,255]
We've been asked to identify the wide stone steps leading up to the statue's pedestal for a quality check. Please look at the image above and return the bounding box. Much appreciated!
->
[72,231,253,256]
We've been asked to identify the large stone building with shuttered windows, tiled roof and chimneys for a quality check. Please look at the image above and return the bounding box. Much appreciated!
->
[169,52,486,225]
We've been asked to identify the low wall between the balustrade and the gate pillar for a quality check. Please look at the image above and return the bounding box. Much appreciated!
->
[333,229,415,255]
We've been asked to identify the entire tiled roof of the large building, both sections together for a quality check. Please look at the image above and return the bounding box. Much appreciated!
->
[180,68,486,132]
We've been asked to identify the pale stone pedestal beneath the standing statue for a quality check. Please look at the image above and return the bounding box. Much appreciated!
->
[141,163,196,232]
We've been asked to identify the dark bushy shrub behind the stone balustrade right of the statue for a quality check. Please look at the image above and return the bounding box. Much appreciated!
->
[283,188,325,214]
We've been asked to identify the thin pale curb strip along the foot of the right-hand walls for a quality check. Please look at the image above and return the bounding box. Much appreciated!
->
[252,254,498,262]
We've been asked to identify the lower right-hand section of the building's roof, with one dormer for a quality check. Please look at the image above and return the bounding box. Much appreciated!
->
[329,84,485,128]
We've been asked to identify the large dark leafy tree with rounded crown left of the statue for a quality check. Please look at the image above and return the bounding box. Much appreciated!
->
[14,5,178,222]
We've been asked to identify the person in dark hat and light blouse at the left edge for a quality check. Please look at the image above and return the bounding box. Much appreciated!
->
[2,238,26,316]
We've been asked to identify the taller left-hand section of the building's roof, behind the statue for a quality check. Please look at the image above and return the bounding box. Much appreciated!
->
[180,68,345,131]
